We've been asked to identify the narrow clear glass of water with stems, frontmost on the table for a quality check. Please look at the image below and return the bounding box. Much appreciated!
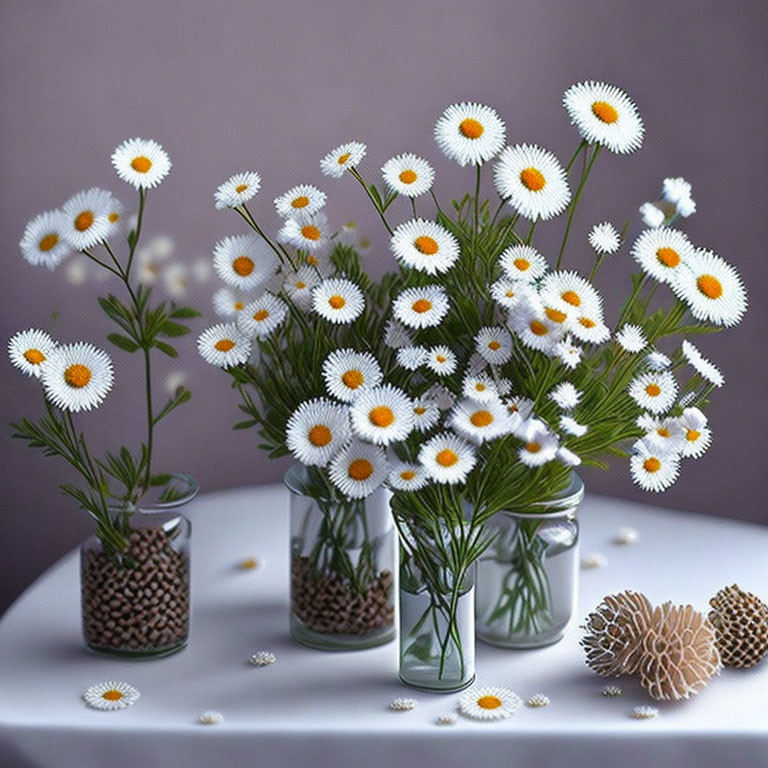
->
[399,548,475,693]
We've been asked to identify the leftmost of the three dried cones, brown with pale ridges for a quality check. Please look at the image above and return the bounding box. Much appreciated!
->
[581,590,653,677]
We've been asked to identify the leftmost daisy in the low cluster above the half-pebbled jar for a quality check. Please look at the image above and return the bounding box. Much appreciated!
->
[285,397,351,467]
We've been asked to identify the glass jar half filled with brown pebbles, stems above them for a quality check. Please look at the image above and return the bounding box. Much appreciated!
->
[285,464,396,651]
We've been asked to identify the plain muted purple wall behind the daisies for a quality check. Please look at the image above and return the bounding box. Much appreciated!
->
[0,0,768,609]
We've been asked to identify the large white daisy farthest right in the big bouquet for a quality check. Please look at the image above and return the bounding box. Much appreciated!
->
[671,248,747,326]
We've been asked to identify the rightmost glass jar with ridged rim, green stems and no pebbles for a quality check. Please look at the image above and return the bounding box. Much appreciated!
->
[476,473,584,648]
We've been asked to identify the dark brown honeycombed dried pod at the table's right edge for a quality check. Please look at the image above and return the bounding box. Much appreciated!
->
[709,584,768,667]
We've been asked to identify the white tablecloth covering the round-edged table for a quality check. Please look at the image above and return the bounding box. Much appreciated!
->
[0,485,768,768]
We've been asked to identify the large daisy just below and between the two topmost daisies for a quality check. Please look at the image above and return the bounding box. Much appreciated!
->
[493,144,571,221]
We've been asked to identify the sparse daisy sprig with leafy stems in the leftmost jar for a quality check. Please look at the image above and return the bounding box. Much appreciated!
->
[8,139,199,563]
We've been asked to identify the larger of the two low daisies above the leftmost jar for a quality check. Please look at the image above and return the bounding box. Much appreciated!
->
[40,341,114,413]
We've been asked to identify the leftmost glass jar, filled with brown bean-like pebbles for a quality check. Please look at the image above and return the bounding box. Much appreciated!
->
[80,473,198,658]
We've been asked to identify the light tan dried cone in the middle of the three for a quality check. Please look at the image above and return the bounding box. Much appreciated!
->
[638,603,721,700]
